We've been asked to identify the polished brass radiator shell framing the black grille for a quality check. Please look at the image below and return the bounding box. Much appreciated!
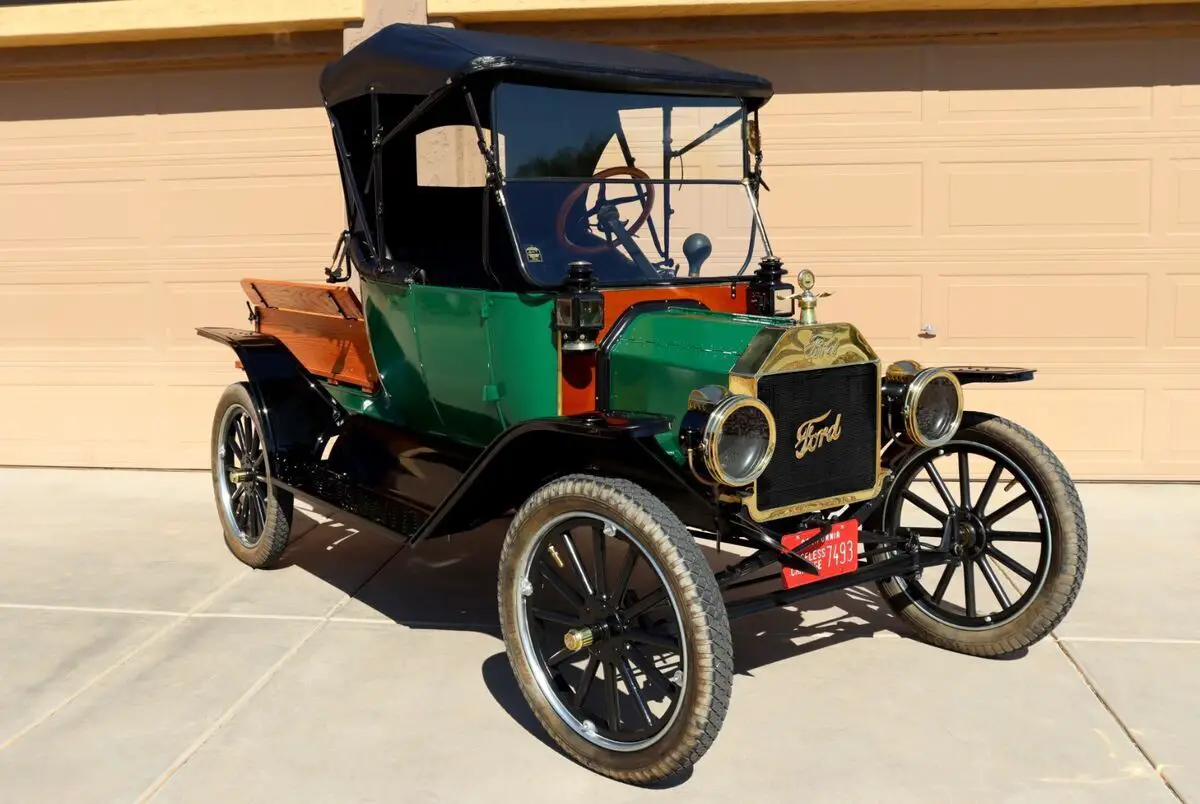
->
[730,323,889,522]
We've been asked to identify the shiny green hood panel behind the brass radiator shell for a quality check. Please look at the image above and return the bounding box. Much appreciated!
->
[608,307,780,462]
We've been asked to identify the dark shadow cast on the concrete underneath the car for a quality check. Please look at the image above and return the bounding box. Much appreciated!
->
[282,510,907,785]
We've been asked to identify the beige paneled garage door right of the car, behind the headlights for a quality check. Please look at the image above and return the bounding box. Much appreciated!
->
[697,41,1200,479]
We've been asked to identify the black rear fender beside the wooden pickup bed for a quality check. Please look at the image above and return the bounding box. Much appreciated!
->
[196,326,346,463]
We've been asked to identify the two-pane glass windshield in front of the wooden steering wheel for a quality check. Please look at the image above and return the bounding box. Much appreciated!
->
[494,84,762,284]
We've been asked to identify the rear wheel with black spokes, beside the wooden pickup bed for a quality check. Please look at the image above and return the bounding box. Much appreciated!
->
[212,383,293,569]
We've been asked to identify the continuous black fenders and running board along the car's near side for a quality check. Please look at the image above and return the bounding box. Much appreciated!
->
[197,328,713,544]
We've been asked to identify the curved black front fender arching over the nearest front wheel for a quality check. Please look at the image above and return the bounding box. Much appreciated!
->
[415,412,713,541]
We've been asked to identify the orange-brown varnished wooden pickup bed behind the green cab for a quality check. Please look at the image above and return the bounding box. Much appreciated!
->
[241,278,379,391]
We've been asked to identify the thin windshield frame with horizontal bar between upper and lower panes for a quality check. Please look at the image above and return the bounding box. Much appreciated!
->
[475,80,774,289]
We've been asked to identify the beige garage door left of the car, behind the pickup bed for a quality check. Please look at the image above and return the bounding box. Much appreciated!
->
[0,65,342,467]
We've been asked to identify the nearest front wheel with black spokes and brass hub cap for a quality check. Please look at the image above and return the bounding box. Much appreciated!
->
[499,475,733,784]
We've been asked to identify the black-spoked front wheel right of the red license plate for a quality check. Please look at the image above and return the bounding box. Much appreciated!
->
[878,414,1087,656]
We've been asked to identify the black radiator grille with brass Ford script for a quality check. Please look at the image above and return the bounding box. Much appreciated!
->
[756,364,880,510]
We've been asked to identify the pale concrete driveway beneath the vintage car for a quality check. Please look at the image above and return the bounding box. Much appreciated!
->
[0,469,1200,804]
